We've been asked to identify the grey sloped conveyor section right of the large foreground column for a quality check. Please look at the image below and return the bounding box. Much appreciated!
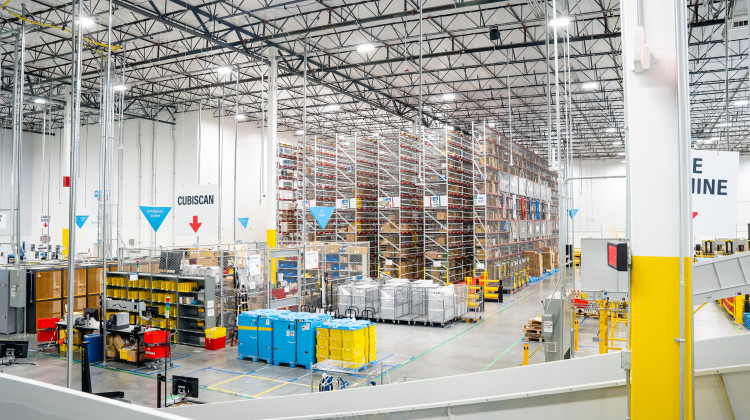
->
[692,252,750,304]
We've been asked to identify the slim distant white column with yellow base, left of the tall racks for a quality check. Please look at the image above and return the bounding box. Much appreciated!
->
[266,47,279,247]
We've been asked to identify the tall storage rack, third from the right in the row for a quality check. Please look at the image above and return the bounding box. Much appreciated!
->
[377,132,424,279]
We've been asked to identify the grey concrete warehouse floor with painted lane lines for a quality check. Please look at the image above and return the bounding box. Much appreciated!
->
[4,275,747,407]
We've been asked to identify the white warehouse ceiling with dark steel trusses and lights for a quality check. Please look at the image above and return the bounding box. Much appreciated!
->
[0,0,750,158]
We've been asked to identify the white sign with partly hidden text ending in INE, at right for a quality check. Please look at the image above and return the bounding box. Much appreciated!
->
[690,150,740,238]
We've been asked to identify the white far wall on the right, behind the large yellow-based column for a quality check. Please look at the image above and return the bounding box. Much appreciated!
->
[572,156,750,247]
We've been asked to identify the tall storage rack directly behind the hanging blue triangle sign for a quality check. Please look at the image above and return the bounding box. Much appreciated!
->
[303,136,337,242]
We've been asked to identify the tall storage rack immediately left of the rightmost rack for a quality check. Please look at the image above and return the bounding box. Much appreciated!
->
[423,128,474,283]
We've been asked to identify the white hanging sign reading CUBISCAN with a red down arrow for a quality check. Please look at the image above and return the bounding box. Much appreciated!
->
[174,185,219,236]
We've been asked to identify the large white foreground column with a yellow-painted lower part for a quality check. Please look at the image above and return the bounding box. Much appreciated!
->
[622,0,693,419]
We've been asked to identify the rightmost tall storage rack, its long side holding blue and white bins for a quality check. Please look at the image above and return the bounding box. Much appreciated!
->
[472,124,557,280]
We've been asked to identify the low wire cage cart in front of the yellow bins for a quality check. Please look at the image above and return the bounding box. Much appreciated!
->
[310,359,384,392]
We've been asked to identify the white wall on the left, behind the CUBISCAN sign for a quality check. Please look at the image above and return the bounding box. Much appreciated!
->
[0,111,296,261]
